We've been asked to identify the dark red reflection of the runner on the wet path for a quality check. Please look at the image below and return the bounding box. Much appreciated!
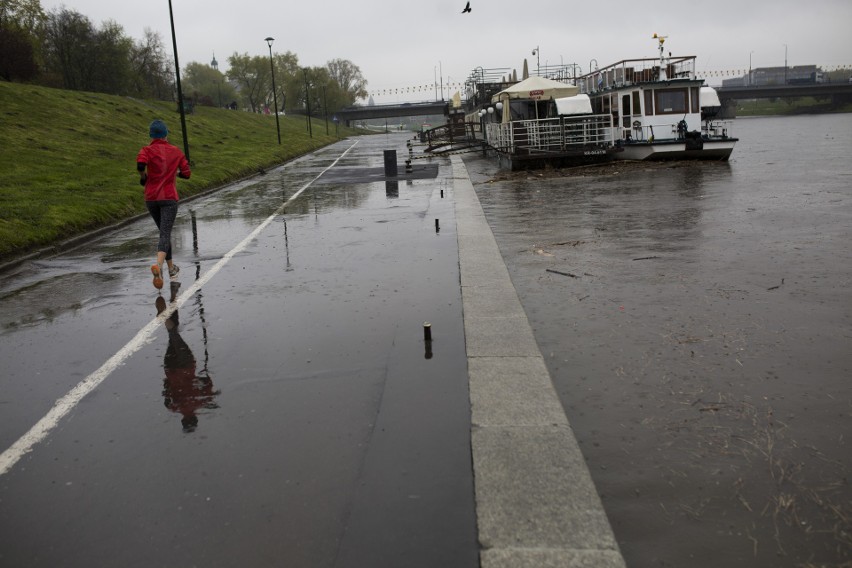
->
[156,282,219,432]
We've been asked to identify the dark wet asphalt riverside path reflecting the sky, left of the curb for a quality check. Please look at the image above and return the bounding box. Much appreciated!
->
[0,135,478,567]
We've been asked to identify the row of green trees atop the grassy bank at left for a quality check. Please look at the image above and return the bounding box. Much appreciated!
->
[0,0,367,115]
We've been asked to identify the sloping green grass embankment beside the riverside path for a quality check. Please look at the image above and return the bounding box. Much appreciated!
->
[0,82,357,262]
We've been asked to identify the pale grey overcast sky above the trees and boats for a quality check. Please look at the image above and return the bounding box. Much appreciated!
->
[41,0,852,103]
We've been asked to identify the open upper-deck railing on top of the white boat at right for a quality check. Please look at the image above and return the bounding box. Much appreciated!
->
[577,55,695,94]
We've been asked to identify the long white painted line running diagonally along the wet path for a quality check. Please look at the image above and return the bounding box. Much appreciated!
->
[0,140,358,475]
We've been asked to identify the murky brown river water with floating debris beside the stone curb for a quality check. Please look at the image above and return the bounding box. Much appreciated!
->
[465,114,852,567]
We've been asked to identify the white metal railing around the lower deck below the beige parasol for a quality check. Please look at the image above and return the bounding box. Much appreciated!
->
[485,114,613,154]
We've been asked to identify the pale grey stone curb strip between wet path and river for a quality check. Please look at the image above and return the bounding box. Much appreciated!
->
[451,156,626,568]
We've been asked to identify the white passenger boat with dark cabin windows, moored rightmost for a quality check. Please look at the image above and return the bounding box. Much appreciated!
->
[578,34,737,160]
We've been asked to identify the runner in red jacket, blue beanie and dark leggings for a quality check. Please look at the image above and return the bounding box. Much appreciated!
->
[136,120,191,289]
